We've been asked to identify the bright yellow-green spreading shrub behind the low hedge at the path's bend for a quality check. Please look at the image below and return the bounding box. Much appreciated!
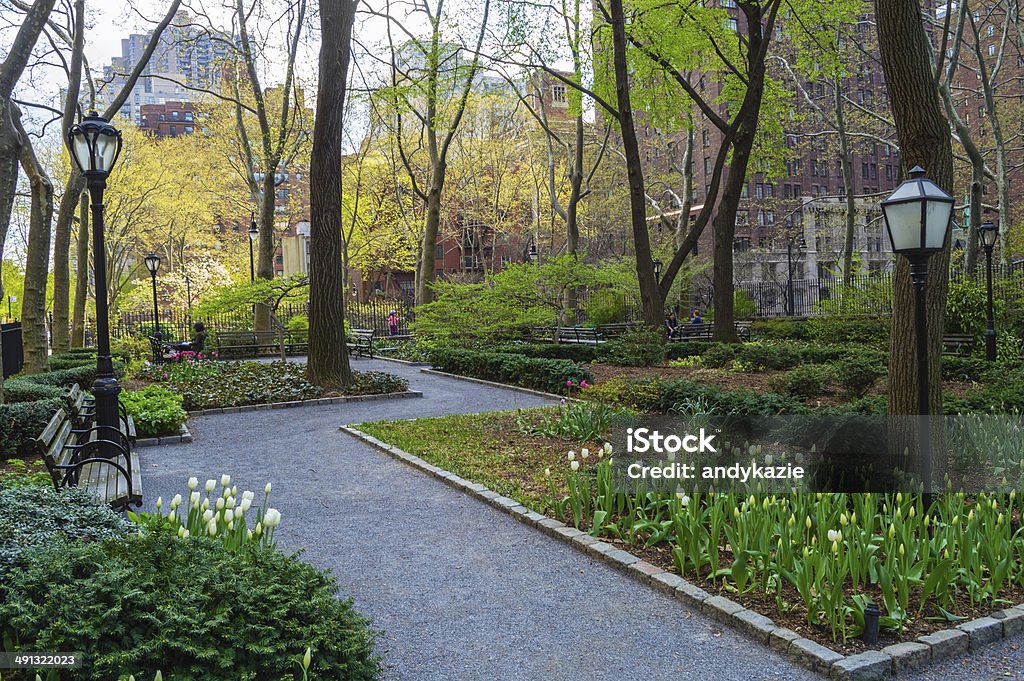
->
[413,255,593,341]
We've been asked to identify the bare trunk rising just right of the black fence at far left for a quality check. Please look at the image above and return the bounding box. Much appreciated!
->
[18,112,53,374]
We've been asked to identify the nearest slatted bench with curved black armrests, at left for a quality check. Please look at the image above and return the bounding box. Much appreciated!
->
[34,408,142,510]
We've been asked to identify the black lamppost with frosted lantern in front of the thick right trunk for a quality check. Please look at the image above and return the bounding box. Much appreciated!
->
[882,161,953,513]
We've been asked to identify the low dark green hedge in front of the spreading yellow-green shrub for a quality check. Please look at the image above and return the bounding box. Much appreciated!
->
[430,349,594,393]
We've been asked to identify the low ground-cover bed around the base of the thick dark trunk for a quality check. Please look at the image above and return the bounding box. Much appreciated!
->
[136,360,409,411]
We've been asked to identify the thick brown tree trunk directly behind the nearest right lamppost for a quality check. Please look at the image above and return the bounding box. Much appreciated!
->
[874,0,953,415]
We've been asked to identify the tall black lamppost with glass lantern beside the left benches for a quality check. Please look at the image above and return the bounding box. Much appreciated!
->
[68,112,121,440]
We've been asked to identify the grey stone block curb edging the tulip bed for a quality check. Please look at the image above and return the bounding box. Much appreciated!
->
[339,426,1024,681]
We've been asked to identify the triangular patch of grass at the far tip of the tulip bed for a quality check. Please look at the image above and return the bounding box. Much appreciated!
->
[357,408,596,512]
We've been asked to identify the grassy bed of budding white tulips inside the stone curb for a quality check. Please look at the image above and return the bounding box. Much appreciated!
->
[358,412,1024,652]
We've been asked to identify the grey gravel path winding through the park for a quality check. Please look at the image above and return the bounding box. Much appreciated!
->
[141,360,816,681]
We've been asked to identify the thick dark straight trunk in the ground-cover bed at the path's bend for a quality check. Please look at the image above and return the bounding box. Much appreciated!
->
[308,0,358,387]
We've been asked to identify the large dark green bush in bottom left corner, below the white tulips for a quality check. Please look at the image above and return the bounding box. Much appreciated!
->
[0,530,379,681]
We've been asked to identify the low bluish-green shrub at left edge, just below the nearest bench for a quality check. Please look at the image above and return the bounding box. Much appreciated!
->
[0,483,130,573]
